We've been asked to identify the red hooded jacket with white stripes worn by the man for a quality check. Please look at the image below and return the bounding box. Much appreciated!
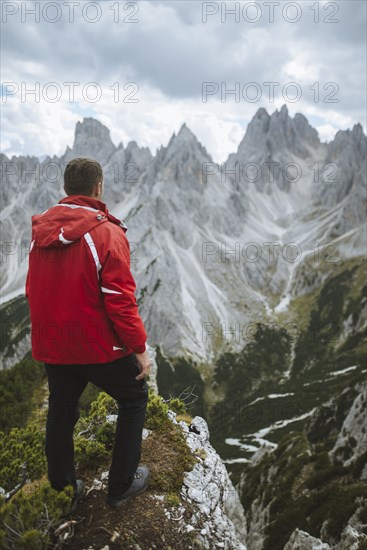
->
[26,195,147,364]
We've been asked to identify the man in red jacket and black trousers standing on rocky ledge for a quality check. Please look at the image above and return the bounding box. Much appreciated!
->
[26,158,150,511]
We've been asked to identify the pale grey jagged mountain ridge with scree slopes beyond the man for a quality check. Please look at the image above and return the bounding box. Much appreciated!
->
[0,105,367,360]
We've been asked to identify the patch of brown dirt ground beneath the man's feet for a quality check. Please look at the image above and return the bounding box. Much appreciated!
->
[56,433,200,550]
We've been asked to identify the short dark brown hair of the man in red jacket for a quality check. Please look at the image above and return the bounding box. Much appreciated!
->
[64,157,103,197]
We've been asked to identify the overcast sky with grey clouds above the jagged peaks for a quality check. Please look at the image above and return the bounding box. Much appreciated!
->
[1,0,367,161]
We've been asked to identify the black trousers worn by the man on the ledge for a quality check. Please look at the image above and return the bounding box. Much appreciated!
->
[45,353,148,497]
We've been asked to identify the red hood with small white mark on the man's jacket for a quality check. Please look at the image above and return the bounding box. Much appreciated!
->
[32,195,127,248]
